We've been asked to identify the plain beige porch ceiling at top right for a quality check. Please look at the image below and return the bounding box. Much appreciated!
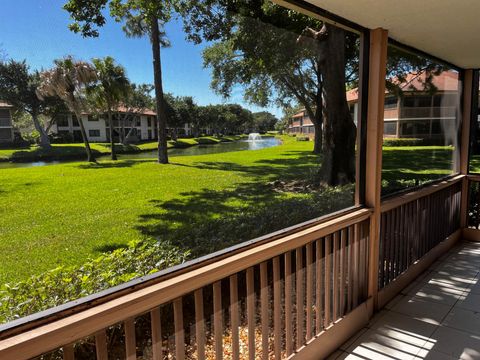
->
[307,0,480,69]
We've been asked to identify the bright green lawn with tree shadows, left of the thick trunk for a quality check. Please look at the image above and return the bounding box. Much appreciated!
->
[0,136,326,282]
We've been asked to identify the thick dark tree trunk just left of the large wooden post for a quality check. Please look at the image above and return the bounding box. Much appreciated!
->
[321,25,356,185]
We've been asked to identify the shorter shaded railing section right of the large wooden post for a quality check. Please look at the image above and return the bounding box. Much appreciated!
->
[378,175,463,289]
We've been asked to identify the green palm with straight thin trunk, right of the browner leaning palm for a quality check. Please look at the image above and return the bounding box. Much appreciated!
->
[87,56,130,160]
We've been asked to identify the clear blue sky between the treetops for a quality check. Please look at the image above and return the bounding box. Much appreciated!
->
[0,0,281,116]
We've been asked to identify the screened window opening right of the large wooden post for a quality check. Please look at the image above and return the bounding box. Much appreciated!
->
[382,45,462,195]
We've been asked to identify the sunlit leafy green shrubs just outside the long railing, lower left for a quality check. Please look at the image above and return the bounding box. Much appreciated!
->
[0,243,188,323]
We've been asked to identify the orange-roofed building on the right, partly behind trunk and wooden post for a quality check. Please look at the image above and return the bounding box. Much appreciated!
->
[287,71,460,139]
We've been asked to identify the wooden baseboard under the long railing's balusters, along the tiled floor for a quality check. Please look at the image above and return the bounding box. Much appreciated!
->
[289,301,369,360]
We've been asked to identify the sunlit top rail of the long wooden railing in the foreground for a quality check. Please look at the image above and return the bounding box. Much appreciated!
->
[0,209,372,359]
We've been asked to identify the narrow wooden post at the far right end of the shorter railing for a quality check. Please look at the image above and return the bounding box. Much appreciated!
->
[456,69,477,228]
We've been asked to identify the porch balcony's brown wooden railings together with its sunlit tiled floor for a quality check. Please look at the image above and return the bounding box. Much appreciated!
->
[0,175,480,359]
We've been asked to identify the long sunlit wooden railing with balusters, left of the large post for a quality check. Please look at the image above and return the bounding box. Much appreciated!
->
[0,209,371,359]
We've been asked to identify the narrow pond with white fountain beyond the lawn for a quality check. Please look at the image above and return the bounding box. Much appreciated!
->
[0,137,281,169]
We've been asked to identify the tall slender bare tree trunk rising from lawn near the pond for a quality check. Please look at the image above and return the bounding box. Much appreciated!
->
[151,18,168,164]
